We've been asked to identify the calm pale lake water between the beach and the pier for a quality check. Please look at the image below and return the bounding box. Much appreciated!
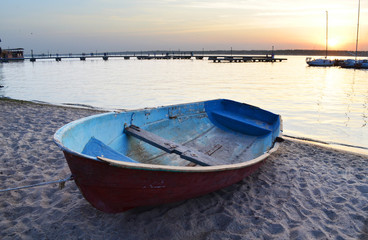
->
[0,56,368,153]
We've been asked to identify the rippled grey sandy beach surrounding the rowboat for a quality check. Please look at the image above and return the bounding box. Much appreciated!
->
[0,100,368,240]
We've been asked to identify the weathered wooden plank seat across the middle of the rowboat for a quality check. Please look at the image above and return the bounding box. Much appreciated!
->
[124,125,228,166]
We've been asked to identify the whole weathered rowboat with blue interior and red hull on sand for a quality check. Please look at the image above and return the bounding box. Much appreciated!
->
[54,99,282,213]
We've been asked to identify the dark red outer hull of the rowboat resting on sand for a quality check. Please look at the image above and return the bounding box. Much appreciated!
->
[64,151,264,213]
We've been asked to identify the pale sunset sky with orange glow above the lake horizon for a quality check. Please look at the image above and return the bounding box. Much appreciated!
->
[0,0,368,53]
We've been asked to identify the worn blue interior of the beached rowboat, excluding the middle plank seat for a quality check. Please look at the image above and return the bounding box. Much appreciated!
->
[55,99,281,166]
